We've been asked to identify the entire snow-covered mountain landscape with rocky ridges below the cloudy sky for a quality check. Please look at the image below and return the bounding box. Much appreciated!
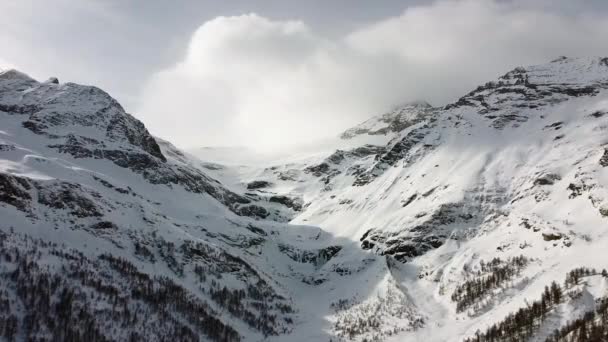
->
[0,58,608,341]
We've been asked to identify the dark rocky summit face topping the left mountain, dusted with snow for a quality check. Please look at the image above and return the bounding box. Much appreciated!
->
[0,72,166,162]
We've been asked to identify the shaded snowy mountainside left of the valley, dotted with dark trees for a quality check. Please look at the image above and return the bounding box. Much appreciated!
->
[0,71,344,341]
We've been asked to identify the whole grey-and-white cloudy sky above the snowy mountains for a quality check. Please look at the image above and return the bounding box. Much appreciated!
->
[0,0,608,150]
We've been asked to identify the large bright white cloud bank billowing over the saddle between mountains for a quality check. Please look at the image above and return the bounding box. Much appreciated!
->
[137,0,608,149]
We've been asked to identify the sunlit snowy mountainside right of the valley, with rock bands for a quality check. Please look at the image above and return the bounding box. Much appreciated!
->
[211,58,608,341]
